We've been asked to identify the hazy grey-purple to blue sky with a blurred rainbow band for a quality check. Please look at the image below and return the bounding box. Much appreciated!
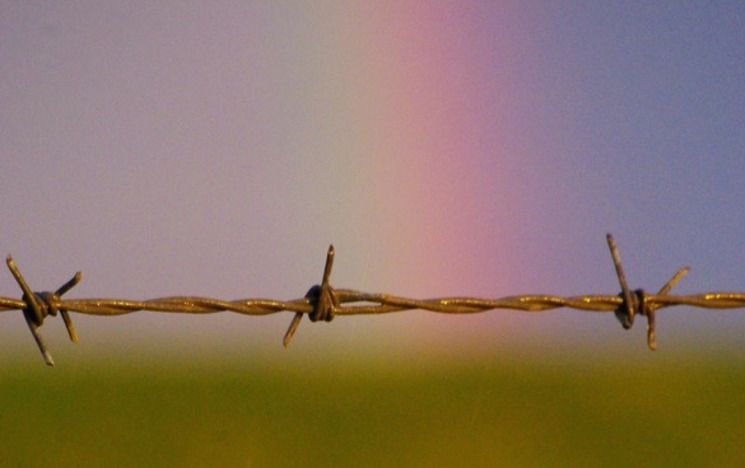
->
[0,1,745,356]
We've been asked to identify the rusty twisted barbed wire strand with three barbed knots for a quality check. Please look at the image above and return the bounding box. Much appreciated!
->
[0,234,745,366]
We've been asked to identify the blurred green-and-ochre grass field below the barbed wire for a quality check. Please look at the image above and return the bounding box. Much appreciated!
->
[0,353,745,467]
